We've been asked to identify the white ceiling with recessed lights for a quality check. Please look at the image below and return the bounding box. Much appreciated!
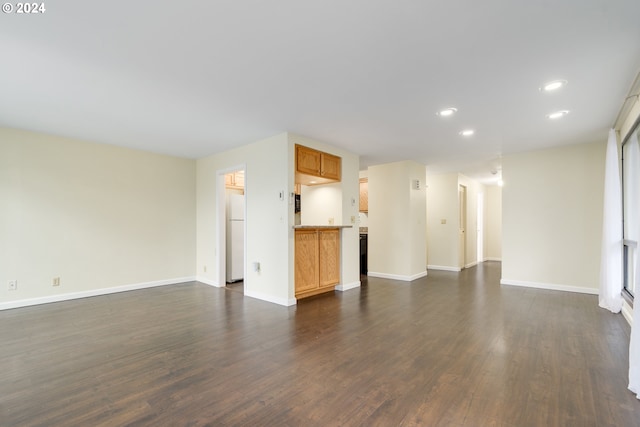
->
[0,0,640,184]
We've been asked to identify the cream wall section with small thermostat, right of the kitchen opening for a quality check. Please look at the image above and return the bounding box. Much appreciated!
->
[368,161,427,280]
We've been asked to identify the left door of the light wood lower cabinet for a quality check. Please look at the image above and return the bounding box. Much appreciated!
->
[294,230,318,293]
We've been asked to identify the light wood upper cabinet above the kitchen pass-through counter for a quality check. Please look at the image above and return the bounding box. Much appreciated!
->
[296,145,342,185]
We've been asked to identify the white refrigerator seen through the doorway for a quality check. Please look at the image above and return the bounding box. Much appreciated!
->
[226,194,244,283]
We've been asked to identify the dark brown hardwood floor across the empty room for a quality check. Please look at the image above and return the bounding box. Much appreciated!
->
[0,263,640,427]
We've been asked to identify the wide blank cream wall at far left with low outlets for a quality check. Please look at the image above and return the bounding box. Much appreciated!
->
[0,129,196,308]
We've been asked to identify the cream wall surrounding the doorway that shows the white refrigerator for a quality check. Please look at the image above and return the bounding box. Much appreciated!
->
[197,133,295,305]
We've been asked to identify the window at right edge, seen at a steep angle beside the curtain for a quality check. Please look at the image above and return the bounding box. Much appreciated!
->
[622,124,640,297]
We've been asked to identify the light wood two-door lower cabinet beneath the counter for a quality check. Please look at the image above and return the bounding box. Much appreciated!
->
[295,228,340,298]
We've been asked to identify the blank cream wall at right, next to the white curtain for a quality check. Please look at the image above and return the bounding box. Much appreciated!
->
[502,141,605,293]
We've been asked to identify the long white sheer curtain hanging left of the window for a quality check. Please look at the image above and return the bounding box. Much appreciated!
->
[599,129,622,313]
